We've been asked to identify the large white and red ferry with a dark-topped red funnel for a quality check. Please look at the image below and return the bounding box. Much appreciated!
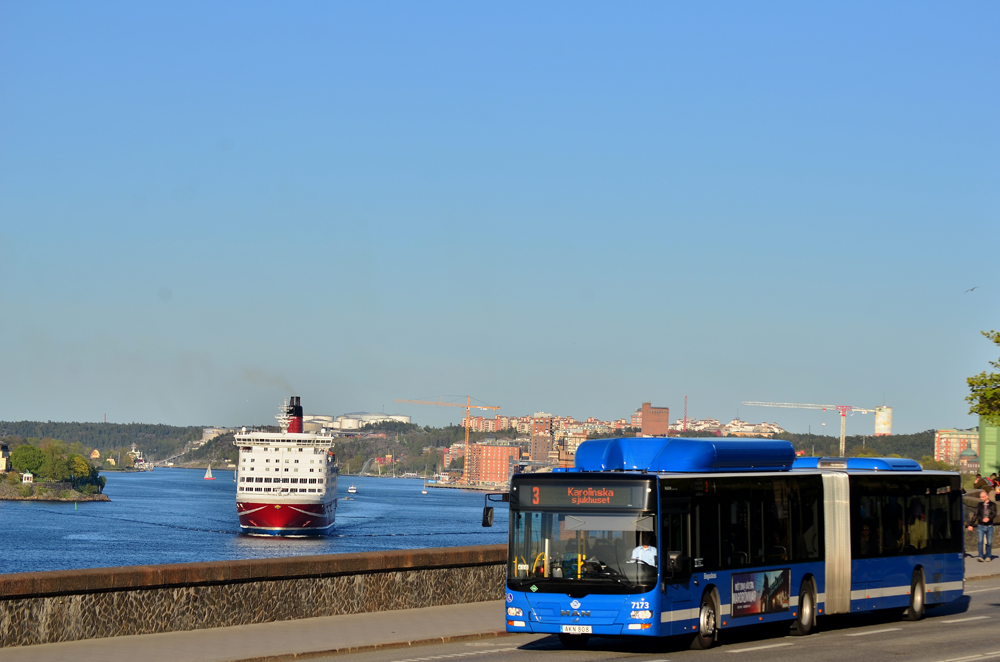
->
[233,396,339,537]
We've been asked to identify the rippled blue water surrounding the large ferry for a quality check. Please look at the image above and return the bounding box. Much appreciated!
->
[0,469,507,573]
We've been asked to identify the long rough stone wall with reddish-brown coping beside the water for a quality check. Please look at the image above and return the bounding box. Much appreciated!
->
[0,545,507,646]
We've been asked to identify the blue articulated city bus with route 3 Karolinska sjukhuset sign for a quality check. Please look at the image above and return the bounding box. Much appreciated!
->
[496,438,964,648]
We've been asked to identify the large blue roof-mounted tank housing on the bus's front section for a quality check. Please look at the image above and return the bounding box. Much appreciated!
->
[576,437,795,473]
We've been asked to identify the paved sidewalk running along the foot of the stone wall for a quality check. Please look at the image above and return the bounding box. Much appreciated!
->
[0,600,508,662]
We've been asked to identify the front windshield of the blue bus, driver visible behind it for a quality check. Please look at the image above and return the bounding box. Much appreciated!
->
[507,510,659,593]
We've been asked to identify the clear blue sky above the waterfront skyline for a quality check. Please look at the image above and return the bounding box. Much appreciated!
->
[0,1,1000,433]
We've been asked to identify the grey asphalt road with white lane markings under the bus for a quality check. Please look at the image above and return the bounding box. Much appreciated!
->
[330,579,1000,662]
